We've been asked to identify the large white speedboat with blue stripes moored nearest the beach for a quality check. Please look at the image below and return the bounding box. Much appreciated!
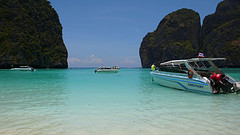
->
[150,58,240,94]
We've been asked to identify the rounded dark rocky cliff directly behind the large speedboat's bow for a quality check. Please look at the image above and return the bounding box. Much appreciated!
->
[139,9,201,68]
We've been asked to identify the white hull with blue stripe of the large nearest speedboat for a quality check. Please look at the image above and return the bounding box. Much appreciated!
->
[150,71,212,94]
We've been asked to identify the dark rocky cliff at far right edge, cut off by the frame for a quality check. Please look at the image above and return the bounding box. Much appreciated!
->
[201,0,240,67]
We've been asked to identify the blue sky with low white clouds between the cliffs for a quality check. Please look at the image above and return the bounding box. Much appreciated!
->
[49,0,222,68]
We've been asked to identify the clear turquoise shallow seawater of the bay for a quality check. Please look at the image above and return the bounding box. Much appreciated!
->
[0,69,240,135]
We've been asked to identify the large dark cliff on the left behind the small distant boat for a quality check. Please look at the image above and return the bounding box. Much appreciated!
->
[0,0,68,68]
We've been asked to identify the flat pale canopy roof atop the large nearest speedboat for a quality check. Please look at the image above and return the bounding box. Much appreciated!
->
[160,58,226,65]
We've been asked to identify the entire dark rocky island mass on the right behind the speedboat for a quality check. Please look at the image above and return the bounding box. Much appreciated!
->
[139,0,240,68]
